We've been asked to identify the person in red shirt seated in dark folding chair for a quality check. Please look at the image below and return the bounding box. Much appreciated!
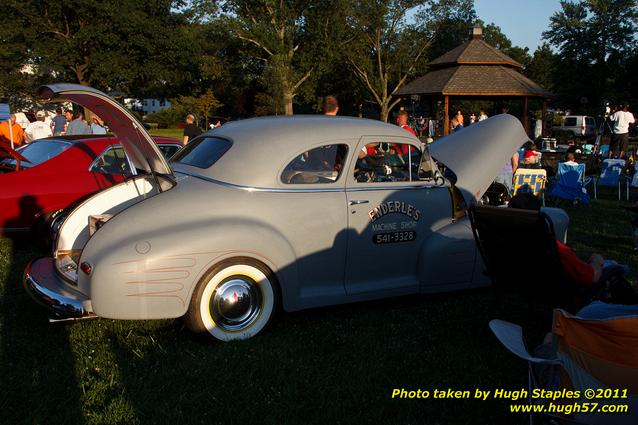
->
[508,192,605,287]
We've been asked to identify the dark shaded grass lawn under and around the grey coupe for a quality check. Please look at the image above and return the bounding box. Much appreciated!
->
[0,195,636,424]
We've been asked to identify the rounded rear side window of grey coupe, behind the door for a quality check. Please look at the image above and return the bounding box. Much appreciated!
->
[281,144,348,184]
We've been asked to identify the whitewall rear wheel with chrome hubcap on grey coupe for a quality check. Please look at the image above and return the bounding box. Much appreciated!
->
[184,258,278,341]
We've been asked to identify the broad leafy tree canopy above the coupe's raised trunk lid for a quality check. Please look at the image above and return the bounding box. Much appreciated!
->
[3,0,195,96]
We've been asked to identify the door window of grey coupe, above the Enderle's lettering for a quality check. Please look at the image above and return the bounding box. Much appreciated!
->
[354,143,422,183]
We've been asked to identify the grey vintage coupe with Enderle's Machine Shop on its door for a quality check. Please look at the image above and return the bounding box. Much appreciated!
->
[24,84,565,340]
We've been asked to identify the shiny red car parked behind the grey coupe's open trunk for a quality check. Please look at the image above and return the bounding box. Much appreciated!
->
[0,135,182,237]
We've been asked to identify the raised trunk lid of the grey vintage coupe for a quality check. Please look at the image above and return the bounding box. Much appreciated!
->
[36,84,172,175]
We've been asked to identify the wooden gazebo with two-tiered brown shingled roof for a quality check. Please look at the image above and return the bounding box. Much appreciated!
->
[398,25,553,135]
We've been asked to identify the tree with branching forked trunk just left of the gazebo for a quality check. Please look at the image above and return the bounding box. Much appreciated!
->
[346,0,430,122]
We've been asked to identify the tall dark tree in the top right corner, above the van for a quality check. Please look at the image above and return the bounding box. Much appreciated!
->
[543,0,638,111]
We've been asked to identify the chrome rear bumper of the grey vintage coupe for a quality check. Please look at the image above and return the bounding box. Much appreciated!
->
[23,258,96,319]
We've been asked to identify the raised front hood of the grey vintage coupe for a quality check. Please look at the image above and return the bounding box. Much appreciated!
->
[428,114,529,206]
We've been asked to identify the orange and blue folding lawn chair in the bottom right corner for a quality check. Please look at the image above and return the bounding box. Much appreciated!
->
[490,309,638,425]
